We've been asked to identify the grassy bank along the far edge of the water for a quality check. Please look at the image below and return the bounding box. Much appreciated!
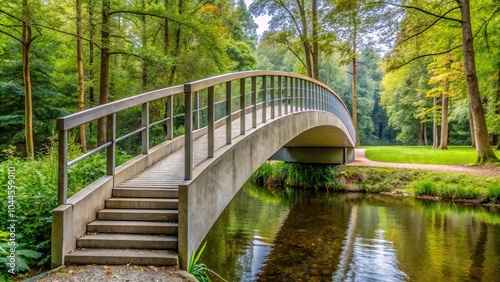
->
[250,162,500,204]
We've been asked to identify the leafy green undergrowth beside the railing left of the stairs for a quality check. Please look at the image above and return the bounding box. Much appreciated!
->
[0,140,129,271]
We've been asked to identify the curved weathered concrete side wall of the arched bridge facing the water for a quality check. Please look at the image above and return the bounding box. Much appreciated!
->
[179,111,354,269]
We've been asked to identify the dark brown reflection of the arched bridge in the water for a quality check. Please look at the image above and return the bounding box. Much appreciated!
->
[259,198,350,281]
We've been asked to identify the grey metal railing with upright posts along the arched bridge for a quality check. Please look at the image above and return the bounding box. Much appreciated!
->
[57,71,356,205]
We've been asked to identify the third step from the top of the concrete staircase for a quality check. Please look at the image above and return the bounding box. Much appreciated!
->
[97,209,178,221]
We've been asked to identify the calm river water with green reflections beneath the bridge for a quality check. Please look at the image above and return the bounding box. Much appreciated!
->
[200,184,500,282]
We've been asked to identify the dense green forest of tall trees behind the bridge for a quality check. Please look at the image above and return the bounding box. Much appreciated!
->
[0,0,500,278]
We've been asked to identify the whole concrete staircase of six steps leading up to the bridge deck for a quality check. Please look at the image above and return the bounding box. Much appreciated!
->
[65,183,178,265]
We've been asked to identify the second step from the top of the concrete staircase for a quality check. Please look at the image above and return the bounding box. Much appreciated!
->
[106,198,179,210]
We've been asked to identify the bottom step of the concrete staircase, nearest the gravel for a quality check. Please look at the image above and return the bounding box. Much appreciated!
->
[64,249,179,265]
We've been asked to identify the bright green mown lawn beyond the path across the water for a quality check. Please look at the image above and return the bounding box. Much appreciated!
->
[363,146,500,165]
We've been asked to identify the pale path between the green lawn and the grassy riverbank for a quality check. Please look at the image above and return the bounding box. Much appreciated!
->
[348,149,500,176]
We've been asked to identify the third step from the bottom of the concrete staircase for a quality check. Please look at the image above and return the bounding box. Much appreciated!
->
[87,220,178,235]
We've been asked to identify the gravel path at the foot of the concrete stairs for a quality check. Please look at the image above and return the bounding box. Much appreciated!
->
[28,265,197,282]
